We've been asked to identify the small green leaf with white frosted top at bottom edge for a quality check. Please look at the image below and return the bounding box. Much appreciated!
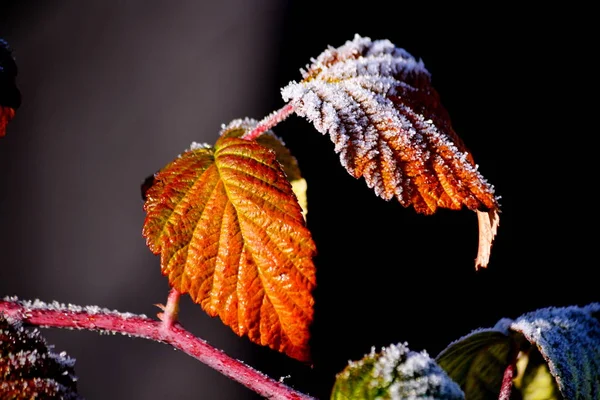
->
[331,344,465,400]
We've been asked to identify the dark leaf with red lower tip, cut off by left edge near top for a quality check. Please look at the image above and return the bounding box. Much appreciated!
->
[0,39,21,137]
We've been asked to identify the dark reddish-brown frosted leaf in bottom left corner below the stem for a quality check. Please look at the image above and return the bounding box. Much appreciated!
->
[0,314,81,400]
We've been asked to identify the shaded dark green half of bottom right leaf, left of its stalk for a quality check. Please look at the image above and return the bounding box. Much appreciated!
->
[435,320,512,400]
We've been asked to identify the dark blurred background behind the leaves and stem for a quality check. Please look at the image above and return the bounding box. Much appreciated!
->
[0,0,600,400]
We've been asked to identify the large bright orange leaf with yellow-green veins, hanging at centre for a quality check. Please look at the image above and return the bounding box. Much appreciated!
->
[143,135,316,361]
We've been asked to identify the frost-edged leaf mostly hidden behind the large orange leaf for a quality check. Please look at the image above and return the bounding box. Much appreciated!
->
[220,118,308,219]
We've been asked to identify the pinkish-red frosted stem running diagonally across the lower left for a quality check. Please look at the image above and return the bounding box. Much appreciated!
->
[0,298,315,400]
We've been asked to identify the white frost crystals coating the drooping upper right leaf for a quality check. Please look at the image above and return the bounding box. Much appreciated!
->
[281,35,494,205]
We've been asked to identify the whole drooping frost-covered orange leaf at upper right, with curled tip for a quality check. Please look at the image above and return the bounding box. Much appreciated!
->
[281,35,499,268]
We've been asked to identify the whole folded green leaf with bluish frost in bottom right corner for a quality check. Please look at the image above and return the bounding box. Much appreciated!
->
[436,303,600,400]
